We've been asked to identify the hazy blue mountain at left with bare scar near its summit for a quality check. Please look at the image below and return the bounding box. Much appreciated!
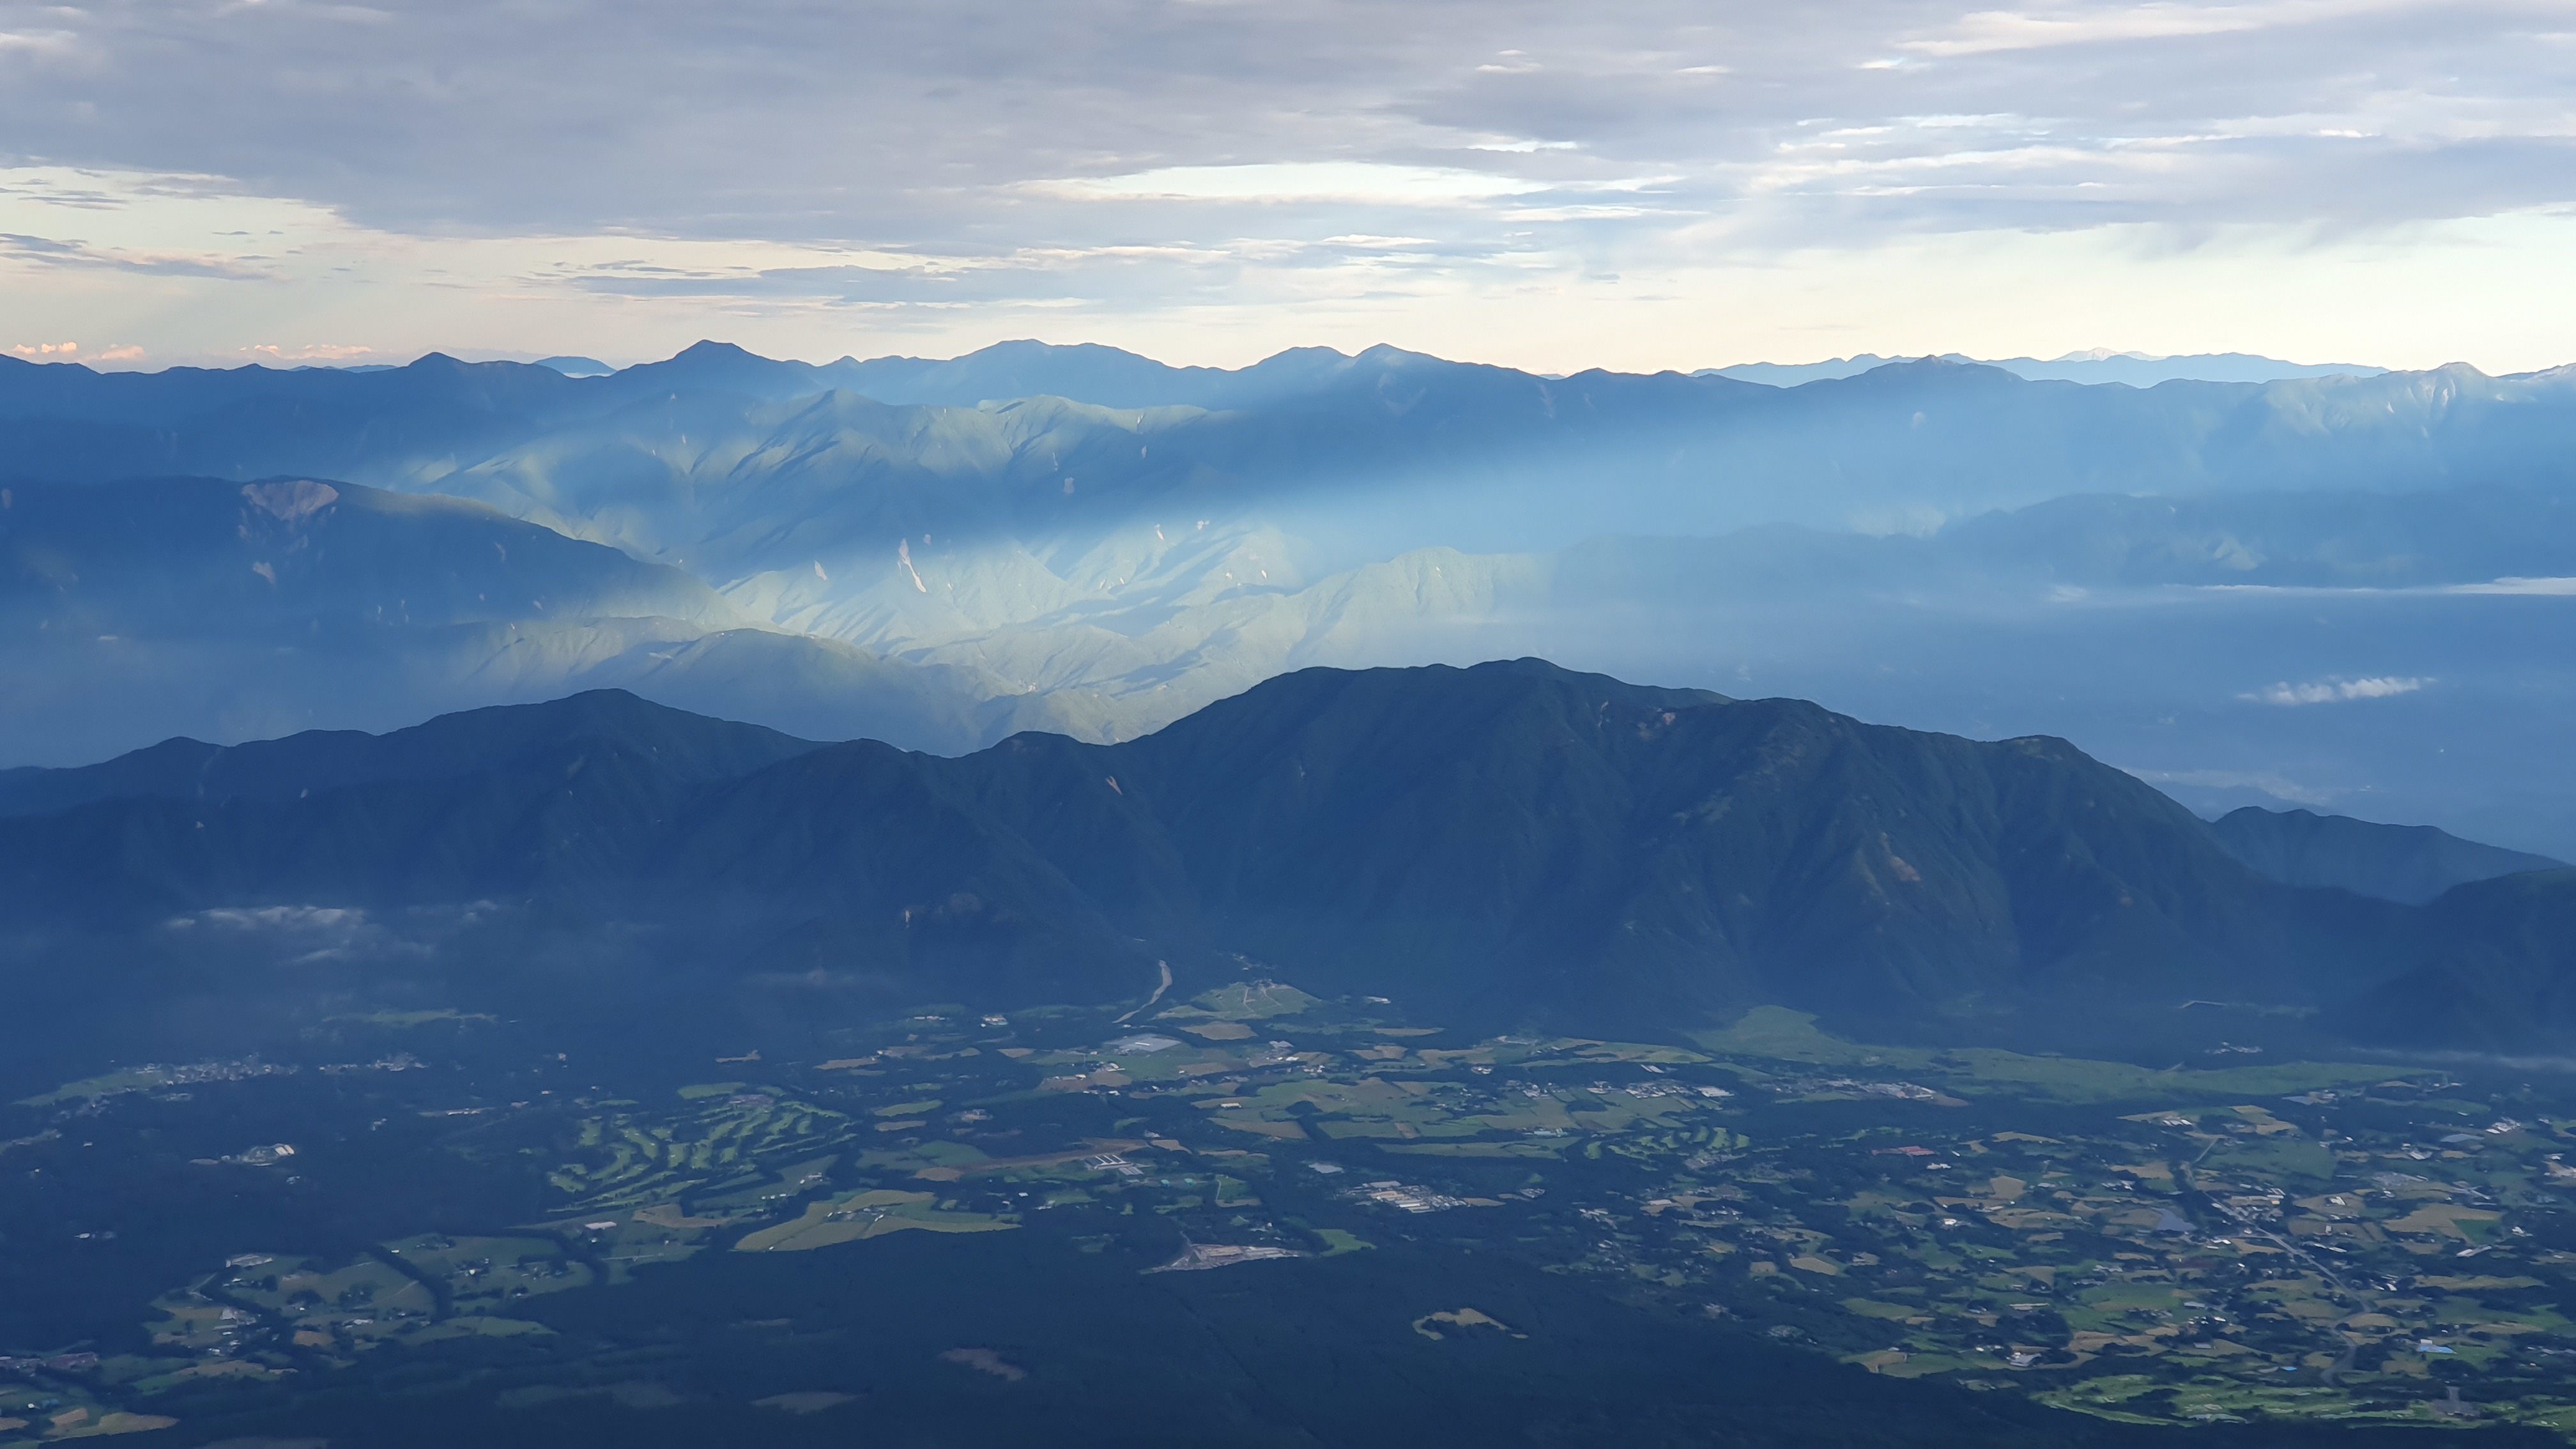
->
[0,480,1090,760]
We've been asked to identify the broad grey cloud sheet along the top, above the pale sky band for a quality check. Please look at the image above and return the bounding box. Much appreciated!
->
[0,0,2568,247]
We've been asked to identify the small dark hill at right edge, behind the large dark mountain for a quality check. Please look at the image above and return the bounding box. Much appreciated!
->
[2210,804,2566,905]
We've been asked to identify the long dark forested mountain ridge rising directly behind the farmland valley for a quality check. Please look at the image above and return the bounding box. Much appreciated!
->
[0,660,2566,1039]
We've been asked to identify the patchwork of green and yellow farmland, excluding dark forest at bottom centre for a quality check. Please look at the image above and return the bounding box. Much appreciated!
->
[15,983,2576,1444]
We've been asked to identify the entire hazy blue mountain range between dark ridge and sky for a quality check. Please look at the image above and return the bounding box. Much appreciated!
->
[15,343,2576,856]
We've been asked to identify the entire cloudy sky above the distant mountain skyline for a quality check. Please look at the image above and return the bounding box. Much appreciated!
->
[0,0,2576,371]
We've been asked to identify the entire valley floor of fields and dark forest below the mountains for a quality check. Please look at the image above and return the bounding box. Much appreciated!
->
[0,983,2576,1444]
